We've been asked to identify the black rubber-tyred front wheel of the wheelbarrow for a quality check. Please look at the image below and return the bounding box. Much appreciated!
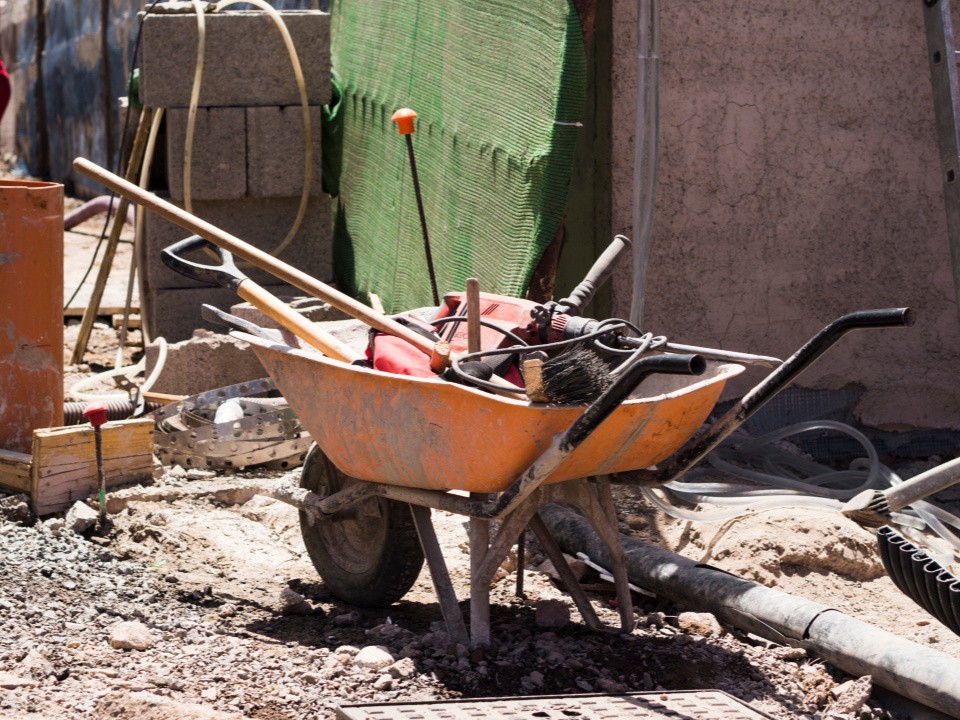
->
[300,444,423,607]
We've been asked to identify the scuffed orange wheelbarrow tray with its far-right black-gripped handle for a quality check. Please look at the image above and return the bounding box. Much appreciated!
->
[239,308,913,506]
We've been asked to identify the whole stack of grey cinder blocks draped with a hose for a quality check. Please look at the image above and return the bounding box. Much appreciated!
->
[140,11,333,341]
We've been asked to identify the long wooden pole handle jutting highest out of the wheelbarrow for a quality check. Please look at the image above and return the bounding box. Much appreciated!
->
[73,158,439,359]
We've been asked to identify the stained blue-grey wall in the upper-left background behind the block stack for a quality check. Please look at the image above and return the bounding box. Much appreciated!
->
[0,0,318,196]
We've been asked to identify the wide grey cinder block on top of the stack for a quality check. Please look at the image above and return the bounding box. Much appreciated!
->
[140,10,330,108]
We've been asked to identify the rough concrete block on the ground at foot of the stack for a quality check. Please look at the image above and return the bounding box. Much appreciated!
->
[146,330,267,395]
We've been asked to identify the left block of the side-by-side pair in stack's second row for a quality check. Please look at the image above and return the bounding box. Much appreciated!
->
[167,107,248,202]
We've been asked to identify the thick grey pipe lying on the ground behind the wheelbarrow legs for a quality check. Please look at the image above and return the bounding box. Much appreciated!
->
[540,505,960,717]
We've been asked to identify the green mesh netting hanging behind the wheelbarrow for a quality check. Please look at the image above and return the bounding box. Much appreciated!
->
[323,0,586,311]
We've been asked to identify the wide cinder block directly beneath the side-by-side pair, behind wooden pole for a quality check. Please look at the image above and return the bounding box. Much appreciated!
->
[140,194,333,292]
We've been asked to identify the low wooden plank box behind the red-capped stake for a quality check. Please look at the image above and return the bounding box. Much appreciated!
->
[0,418,153,515]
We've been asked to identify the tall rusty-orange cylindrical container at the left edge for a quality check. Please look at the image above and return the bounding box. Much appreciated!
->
[0,180,63,453]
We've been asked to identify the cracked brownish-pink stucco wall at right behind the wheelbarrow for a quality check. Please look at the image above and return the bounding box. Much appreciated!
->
[612,0,960,430]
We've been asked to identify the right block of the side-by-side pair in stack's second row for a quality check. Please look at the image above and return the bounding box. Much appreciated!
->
[247,105,322,198]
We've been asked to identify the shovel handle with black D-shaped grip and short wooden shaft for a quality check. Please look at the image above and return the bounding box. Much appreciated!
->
[161,235,366,364]
